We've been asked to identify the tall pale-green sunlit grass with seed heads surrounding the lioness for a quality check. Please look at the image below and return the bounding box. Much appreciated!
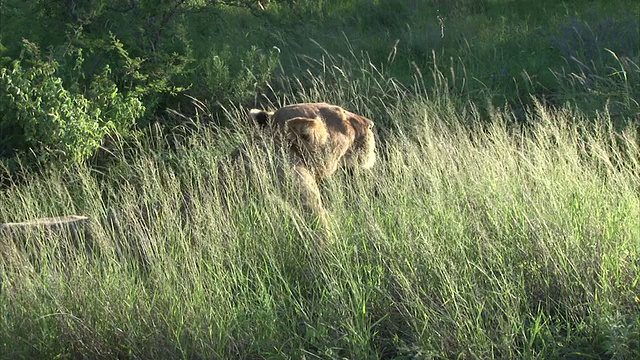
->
[0,52,640,359]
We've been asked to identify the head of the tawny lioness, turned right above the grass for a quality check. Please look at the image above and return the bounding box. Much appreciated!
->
[249,103,376,179]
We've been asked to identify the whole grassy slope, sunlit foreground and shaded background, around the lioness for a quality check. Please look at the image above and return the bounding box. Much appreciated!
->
[0,0,640,359]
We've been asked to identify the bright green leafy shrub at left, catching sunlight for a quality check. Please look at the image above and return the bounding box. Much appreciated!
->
[0,40,145,162]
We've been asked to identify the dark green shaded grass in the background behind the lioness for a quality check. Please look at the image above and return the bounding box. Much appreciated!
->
[184,0,640,123]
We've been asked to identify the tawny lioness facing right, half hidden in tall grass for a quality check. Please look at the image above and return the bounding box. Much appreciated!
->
[219,103,376,225]
